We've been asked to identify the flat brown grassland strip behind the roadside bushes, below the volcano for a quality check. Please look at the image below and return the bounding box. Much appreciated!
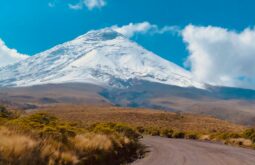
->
[41,105,245,133]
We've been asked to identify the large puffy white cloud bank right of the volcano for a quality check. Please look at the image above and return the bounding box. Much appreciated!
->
[182,25,255,89]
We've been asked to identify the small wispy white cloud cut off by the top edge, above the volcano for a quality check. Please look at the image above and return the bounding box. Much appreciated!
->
[68,0,106,10]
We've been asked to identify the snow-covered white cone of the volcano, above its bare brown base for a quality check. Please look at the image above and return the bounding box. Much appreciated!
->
[0,28,204,88]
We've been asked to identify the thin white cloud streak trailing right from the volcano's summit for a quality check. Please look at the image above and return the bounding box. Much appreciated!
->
[112,22,179,38]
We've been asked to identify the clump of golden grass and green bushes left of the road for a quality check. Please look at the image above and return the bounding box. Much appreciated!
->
[0,107,143,165]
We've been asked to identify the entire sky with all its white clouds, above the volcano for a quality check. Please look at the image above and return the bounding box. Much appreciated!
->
[0,0,255,89]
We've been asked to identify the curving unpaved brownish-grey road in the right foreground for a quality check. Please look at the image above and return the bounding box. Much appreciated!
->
[132,136,255,165]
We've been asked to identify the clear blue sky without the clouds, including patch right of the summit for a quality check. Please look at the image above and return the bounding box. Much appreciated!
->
[0,0,255,65]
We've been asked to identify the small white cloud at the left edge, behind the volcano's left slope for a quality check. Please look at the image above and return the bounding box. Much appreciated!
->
[0,39,28,67]
